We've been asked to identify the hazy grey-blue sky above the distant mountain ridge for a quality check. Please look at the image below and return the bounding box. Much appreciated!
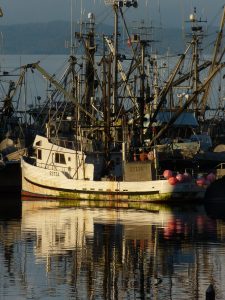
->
[0,0,225,27]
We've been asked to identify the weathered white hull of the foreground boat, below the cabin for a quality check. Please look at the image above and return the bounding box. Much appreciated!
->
[21,159,205,202]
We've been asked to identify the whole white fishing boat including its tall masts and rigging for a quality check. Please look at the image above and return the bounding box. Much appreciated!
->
[21,1,224,203]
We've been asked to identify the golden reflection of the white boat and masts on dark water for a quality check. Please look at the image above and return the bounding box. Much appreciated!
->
[21,202,225,299]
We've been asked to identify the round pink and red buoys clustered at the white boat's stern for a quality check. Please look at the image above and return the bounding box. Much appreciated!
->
[163,170,216,186]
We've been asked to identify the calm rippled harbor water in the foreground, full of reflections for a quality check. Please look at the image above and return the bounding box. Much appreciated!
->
[0,196,225,300]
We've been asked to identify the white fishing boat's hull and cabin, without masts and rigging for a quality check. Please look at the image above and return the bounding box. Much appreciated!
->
[21,136,206,201]
